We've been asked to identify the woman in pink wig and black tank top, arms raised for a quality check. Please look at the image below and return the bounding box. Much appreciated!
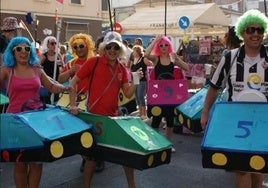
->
[145,35,189,152]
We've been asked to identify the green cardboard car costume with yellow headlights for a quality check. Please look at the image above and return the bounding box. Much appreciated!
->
[77,112,172,170]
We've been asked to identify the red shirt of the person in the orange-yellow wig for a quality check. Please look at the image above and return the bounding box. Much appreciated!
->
[61,59,89,93]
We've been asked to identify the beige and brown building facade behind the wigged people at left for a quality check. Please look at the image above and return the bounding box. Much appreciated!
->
[0,0,103,43]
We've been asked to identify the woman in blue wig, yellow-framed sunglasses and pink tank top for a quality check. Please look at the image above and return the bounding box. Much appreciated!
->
[0,37,69,187]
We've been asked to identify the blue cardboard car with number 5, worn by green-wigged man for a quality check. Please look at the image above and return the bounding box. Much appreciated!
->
[201,102,268,173]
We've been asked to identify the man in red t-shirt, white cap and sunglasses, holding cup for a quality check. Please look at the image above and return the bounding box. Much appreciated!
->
[69,31,142,188]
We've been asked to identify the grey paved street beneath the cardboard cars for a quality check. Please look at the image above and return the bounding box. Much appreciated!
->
[0,117,268,188]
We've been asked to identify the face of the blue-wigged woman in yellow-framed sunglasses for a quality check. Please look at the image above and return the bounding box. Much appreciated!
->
[13,44,31,63]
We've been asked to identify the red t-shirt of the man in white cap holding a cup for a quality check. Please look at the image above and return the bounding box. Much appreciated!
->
[76,56,128,116]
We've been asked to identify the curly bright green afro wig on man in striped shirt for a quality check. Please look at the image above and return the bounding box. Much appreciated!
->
[235,9,268,39]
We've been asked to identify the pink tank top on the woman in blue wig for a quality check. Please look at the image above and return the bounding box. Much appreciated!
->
[7,68,41,113]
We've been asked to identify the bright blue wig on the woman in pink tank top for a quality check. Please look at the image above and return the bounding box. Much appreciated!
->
[3,37,39,67]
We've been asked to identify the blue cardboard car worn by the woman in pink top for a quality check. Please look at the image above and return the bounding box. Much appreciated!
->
[0,107,95,162]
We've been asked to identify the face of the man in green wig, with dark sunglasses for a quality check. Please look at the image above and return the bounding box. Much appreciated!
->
[242,24,264,49]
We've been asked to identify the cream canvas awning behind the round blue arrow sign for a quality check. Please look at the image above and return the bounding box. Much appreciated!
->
[121,3,231,37]
